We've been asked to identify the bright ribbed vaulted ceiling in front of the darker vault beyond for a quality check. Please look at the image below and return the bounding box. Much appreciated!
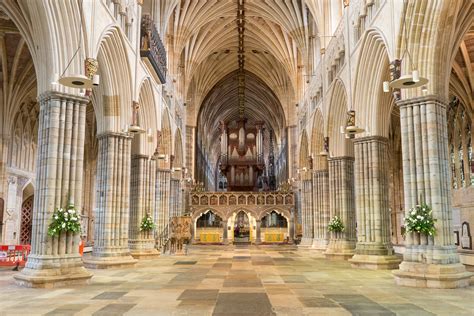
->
[160,0,317,130]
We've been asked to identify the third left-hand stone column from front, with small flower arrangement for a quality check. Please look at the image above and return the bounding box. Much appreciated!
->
[128,155,159,259]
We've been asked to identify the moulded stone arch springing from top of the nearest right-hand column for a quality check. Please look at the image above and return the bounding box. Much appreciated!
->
[397,0,474,100]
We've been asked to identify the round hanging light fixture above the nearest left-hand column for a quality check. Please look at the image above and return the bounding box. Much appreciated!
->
[57,1,99,89]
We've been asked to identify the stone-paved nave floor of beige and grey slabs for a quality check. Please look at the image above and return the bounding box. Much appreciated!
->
[0,246,474,316]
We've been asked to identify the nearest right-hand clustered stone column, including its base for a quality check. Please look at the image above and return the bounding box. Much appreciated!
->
[394,96,472,288]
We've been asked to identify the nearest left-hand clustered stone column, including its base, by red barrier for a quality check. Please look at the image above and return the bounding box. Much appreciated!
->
[14,91,92,287]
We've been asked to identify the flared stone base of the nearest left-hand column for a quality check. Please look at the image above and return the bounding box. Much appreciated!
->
[13,255,92,288]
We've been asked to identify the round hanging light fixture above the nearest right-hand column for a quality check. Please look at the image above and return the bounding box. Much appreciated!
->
[383,0,428,92]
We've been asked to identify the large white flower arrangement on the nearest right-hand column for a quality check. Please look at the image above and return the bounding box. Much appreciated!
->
[404,203,436,236]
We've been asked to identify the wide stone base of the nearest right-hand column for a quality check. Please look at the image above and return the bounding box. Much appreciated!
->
[393,261,474,289]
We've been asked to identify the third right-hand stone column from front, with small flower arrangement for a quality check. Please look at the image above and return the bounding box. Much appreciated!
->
[324,157,356,260]
